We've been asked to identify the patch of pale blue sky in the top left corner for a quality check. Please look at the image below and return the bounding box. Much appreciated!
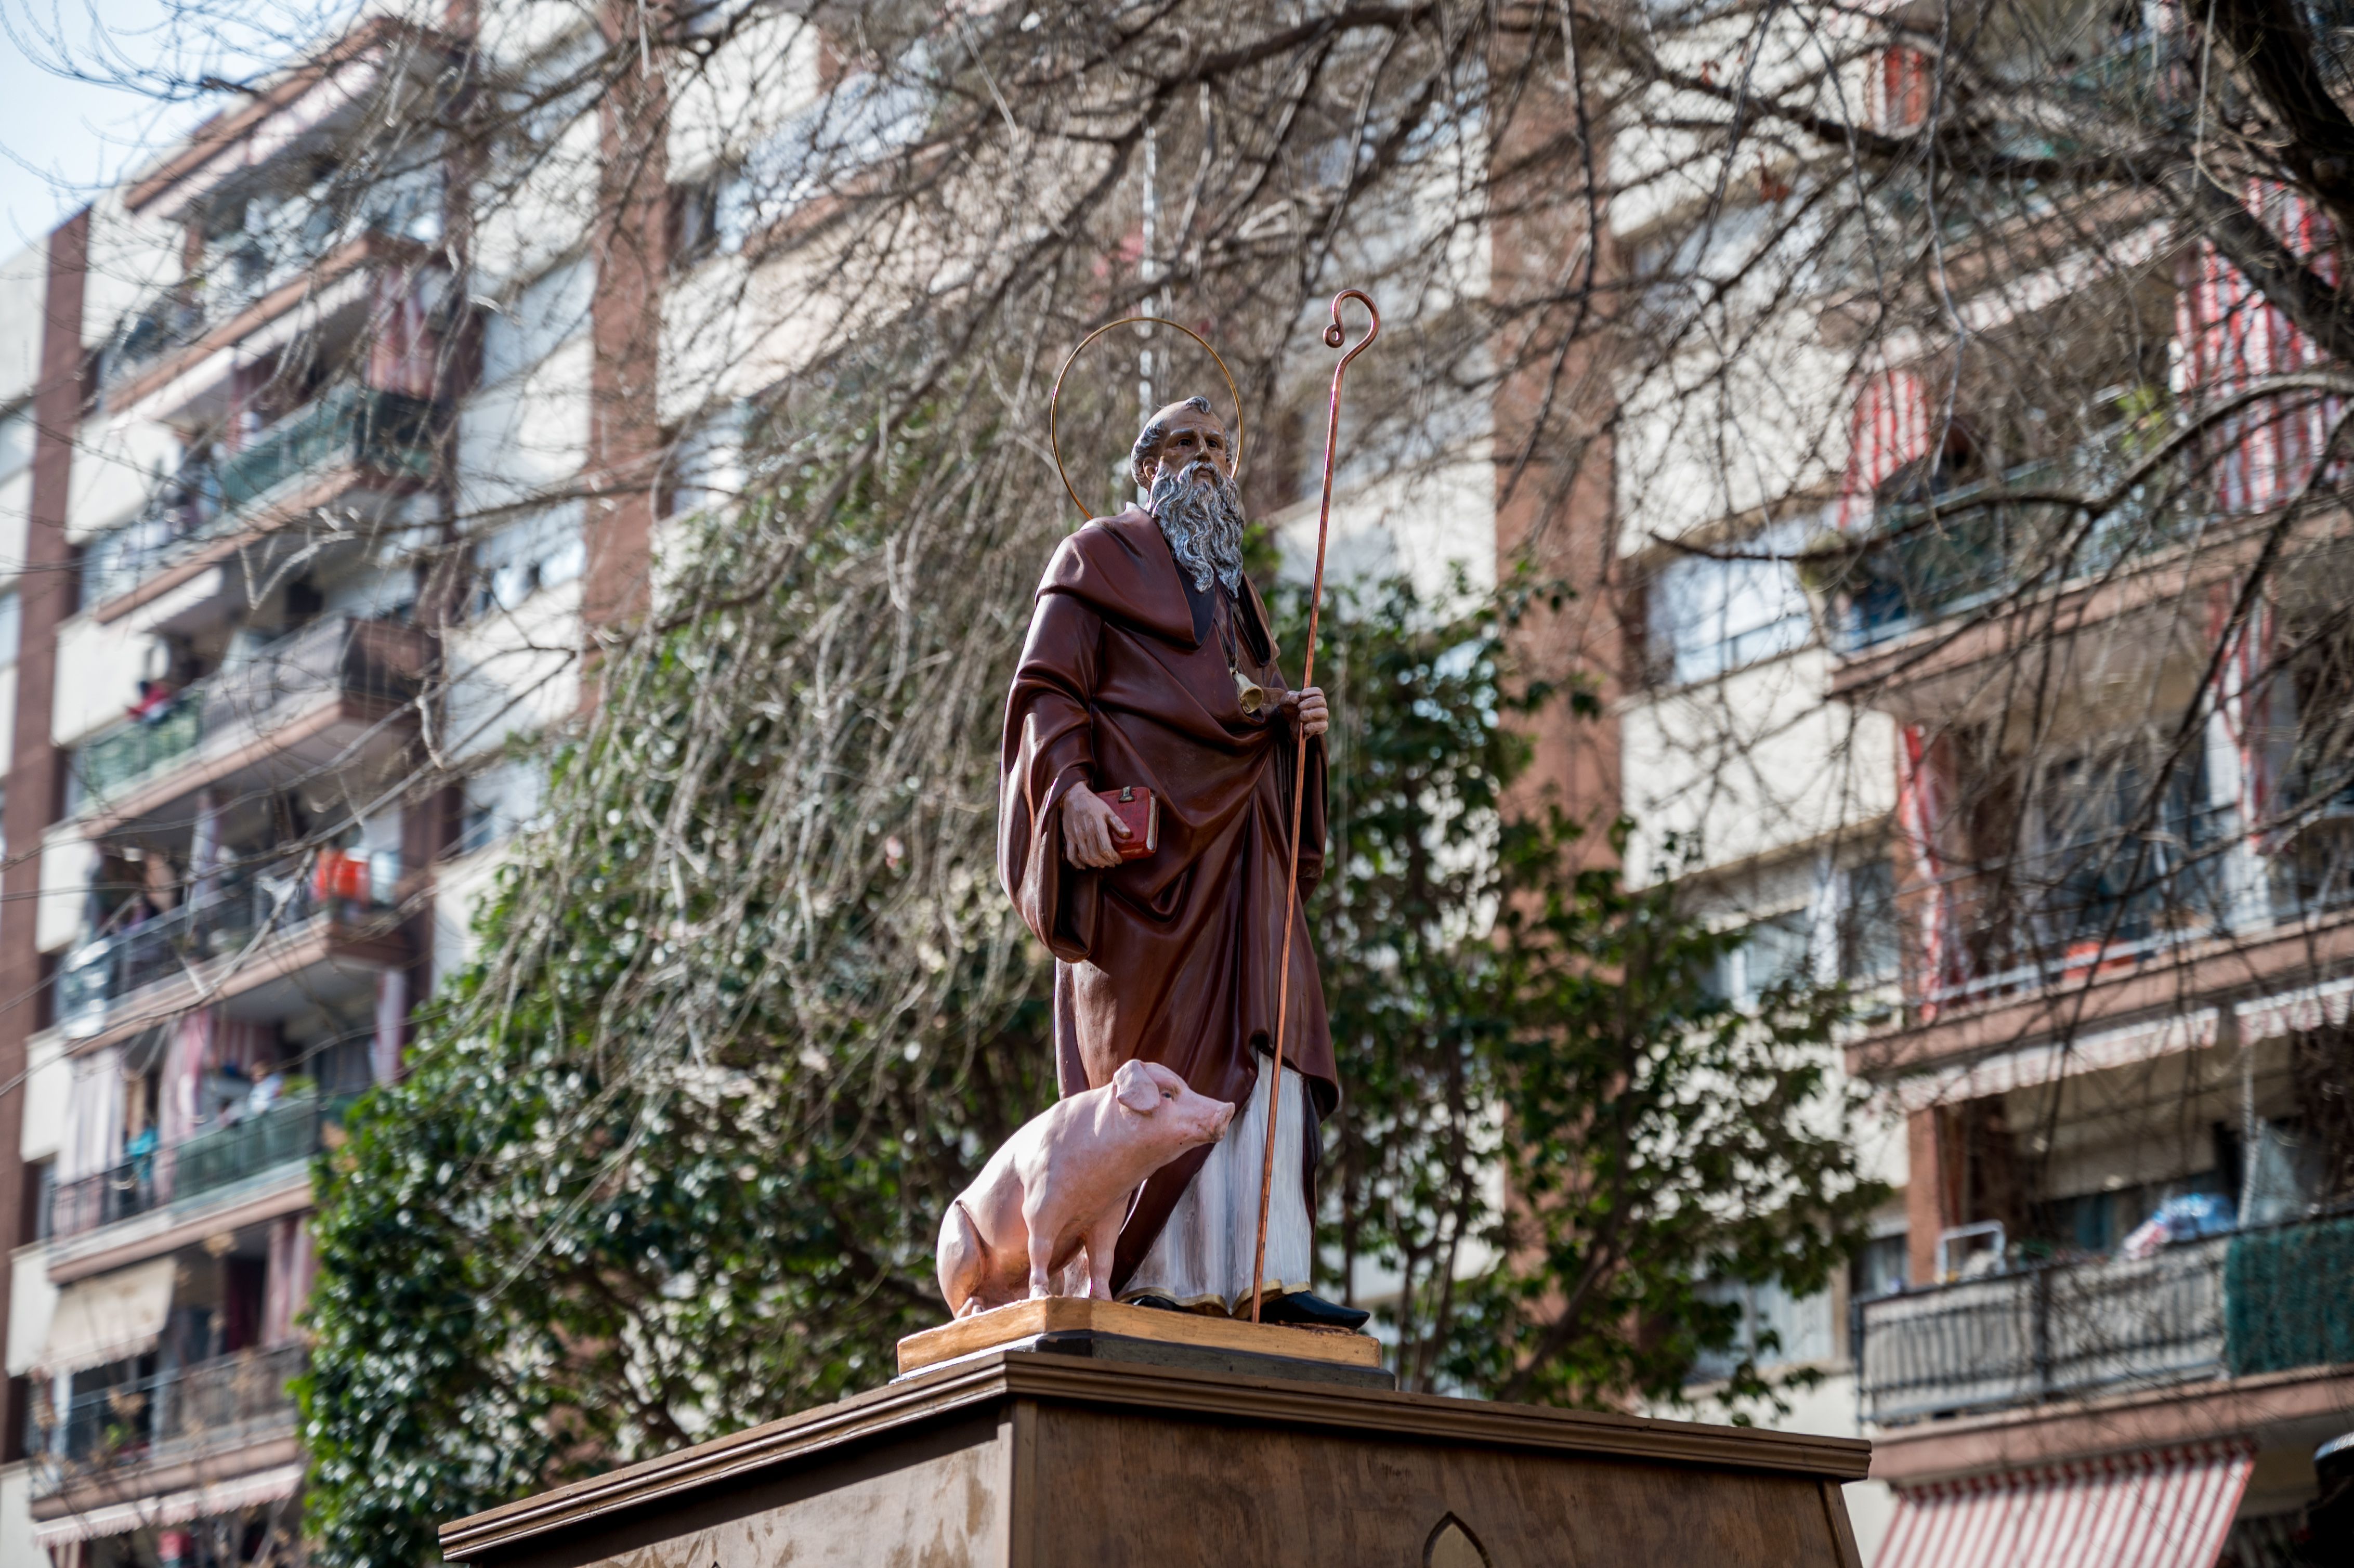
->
[0,0,325,254]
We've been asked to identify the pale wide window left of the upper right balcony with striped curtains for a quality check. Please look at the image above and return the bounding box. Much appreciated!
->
[1650,525,1815,685]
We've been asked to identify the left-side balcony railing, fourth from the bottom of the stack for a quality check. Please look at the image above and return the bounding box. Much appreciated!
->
[75,617,426,801]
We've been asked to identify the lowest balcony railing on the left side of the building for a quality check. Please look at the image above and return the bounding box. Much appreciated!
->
[35,1344,306,1476]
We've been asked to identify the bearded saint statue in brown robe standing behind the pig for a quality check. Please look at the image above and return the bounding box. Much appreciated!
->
[998,398,1368,1328]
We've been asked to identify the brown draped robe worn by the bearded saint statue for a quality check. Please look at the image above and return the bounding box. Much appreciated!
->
[998,506,1339,1290]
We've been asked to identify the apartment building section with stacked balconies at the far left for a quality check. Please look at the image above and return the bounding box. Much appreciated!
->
[0,19,673,1568]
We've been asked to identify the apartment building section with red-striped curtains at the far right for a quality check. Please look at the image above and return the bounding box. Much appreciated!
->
[1613,15,2354,1568]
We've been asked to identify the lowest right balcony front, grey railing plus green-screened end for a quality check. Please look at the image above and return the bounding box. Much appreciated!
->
[1858,1215,2354,1425]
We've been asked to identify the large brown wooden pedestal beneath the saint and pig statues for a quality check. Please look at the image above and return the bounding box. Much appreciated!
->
[442,1337,1869,1568]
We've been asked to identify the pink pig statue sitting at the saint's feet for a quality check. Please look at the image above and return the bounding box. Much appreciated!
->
[939,1062,1234,1318]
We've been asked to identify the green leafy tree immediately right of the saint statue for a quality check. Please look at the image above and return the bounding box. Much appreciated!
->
[1292,584,1886,1408]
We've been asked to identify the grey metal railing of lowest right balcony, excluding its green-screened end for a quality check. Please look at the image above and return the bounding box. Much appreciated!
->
[1853,1220,2345,1422]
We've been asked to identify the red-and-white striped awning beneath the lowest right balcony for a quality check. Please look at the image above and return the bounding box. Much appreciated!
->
[1874,1443,2255,1568]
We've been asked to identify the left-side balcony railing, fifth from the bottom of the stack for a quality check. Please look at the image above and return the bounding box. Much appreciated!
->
[82,386,440,605]
